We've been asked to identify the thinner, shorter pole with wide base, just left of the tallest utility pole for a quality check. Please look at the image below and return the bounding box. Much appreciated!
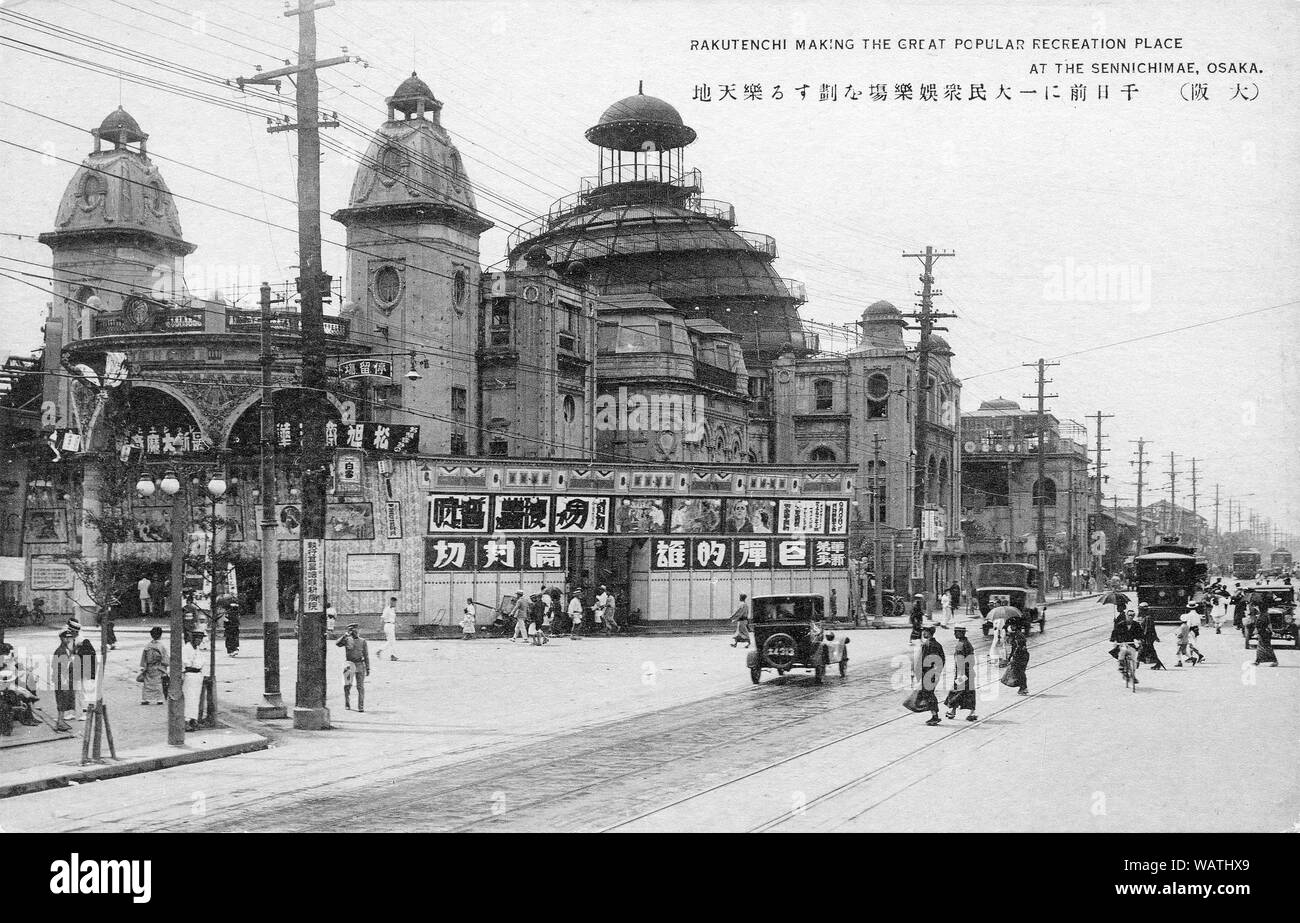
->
[257,282,289,720]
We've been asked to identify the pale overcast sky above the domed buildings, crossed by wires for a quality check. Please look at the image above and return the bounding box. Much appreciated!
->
[0,0,1300,533]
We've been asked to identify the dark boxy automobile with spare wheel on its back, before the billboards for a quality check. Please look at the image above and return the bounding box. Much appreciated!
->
[745,593,849,684]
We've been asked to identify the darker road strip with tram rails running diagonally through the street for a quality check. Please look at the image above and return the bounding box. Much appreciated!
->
[149,605,1109,831]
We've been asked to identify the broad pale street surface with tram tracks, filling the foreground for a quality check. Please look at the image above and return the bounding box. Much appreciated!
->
[0,602,1300,831]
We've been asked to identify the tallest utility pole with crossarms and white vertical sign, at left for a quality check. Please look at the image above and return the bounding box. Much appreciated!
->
[237,0,354,731]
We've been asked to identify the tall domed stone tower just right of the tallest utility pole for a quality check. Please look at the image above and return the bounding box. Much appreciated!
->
[333,73,491,454]
